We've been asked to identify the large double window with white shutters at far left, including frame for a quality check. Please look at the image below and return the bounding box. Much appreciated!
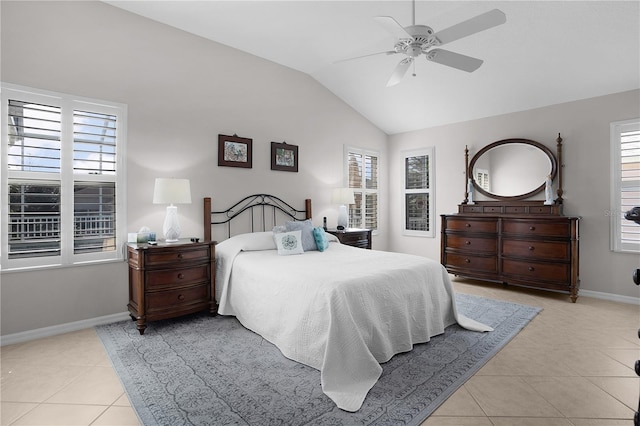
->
[0,84,126,269]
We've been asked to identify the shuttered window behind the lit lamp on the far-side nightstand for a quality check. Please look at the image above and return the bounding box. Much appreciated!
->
[345,147,380,231]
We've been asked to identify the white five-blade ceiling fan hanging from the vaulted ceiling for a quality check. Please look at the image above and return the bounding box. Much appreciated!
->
[336,0,507,86]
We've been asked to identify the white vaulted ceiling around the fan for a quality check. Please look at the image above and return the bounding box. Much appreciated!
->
[107,0,640,134]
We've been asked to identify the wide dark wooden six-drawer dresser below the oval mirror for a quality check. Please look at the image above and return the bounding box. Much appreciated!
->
[441,213,580,302]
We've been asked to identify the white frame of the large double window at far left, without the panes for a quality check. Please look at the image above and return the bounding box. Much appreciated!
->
[0,82,127,271]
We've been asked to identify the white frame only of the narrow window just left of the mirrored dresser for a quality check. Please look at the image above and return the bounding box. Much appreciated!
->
[401,146,436,238]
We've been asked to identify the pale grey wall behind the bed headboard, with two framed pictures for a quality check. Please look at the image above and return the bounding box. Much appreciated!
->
[0,1,388,335]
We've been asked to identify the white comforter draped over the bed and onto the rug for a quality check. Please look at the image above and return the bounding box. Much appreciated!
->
[216,232,492,411]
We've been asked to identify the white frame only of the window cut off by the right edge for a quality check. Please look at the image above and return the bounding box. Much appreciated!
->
[609,118,640,253]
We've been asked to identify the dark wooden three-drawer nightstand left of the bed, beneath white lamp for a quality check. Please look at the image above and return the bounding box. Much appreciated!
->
[127,239,217,334]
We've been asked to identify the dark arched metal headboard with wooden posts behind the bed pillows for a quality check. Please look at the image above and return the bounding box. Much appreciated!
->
[203,194,311,241]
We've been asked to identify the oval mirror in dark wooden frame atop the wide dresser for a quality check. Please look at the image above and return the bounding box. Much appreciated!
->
[465,139,560,201]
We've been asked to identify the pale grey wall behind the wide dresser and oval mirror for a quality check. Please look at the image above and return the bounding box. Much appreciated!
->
[389,90,640,298]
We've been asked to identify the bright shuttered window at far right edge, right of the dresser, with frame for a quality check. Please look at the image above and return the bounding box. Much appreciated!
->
[611,119,640,253]
